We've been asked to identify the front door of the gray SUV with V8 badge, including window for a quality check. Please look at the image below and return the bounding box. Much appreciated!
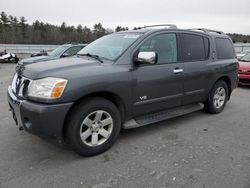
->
[132,33,183,116]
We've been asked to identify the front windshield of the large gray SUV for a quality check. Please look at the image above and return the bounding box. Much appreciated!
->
[78,33,141,60]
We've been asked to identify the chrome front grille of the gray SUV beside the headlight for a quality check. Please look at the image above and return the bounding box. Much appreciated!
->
[11,73,30,98]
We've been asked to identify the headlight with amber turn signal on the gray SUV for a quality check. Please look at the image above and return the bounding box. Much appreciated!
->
[28,77,68,99]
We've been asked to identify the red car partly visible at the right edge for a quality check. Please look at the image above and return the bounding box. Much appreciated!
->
[239,52,250,86]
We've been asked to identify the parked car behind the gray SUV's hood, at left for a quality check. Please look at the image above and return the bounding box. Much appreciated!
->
[17,43,87,69]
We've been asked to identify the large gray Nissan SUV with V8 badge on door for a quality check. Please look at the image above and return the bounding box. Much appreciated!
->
[8,25,238,156]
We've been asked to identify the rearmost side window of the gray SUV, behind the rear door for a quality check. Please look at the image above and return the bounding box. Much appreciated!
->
[215,38,235,59]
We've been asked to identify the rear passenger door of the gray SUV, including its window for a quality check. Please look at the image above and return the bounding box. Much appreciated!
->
[181,33,213,105]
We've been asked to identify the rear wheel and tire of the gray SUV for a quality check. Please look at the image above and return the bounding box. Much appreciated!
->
[205,80,228,114]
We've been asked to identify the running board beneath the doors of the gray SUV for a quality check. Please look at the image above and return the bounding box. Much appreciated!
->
[123,103,204,129]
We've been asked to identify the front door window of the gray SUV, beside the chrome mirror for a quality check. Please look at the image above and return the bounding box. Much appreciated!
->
[139,34,177,64]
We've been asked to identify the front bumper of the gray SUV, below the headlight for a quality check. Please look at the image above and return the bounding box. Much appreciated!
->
[8,86,73,138]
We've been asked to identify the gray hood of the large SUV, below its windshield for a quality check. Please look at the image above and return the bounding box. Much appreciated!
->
[17,57,105,79]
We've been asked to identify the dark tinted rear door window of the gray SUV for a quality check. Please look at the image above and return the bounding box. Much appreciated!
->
[182,34,209,61]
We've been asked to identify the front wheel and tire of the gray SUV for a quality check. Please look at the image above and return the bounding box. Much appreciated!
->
[66,98,121,157]
